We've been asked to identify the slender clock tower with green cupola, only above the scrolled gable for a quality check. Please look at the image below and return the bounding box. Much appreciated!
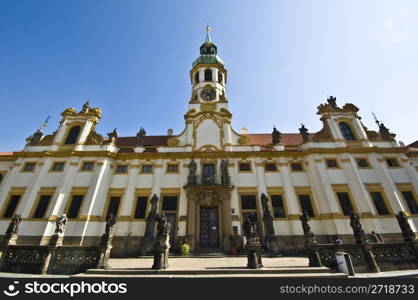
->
[189,26,228,111]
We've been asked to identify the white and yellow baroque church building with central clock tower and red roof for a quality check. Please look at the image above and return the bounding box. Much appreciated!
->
[0,32,418,257]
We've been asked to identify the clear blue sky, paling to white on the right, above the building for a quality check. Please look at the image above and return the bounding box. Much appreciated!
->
[0,0,418,151]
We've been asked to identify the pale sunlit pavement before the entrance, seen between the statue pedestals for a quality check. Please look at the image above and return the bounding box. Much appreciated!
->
[109,257,308,270]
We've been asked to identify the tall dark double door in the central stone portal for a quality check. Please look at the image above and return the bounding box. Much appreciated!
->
[199,206,219,249]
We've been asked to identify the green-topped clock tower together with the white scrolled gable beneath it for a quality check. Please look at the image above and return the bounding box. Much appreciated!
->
[167,26,248,152]
